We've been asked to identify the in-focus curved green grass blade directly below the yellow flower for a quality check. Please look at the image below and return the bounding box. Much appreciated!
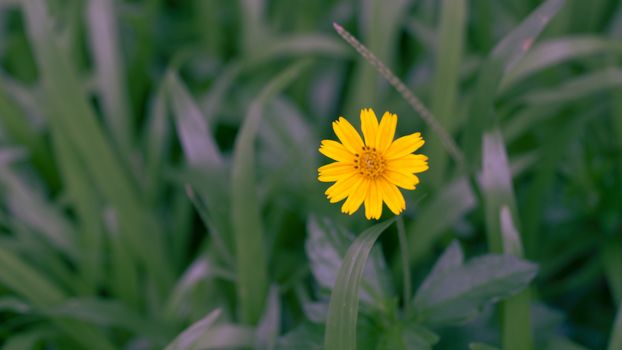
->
[324,220,395,350]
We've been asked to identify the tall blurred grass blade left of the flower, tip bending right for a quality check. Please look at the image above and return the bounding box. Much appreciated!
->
[231,61,309,323]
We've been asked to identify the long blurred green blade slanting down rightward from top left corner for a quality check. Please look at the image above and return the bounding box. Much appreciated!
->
[21,0,173,296]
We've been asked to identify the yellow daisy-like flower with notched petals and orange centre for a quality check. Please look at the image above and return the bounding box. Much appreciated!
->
[318,109,428,219]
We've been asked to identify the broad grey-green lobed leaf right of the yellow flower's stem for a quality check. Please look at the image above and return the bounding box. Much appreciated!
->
[414,245,537,326]
